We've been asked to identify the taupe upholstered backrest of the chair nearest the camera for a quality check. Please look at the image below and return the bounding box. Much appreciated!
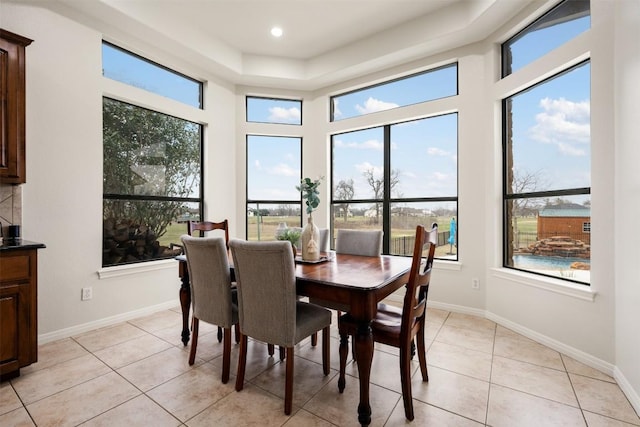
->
[229,239,296,347]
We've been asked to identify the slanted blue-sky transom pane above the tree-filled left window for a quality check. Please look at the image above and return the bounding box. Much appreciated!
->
[102,42,202,108]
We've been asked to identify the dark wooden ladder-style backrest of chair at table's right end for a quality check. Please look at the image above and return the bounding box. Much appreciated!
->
[400,222,438,341]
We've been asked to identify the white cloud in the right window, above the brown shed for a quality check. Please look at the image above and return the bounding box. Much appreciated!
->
[529,98,591,156]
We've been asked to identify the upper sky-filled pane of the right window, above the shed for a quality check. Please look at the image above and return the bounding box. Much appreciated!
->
[505,63,591,194]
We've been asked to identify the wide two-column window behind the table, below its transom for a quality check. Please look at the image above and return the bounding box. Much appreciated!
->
[331,114,458,260]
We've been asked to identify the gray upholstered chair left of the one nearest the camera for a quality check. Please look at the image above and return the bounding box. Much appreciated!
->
[180,234,238,383]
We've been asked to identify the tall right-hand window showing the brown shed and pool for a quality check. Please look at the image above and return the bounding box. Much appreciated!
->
[503,62,591,283]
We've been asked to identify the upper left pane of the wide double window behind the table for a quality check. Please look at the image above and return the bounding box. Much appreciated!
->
[331,127,384,199]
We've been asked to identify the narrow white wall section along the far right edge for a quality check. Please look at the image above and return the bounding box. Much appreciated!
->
[608,0,640,412]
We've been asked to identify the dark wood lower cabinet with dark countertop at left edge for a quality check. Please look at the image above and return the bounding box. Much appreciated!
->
[0,244,44,379]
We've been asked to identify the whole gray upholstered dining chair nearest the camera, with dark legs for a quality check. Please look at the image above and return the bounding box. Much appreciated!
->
[229,239,331,415]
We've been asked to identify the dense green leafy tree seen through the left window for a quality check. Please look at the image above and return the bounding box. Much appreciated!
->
[103,98,201,242]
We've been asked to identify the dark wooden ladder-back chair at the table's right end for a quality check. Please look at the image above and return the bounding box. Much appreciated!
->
[338,223,438,421]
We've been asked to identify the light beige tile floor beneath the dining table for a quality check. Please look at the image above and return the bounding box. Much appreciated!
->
[0,308,640,427]
